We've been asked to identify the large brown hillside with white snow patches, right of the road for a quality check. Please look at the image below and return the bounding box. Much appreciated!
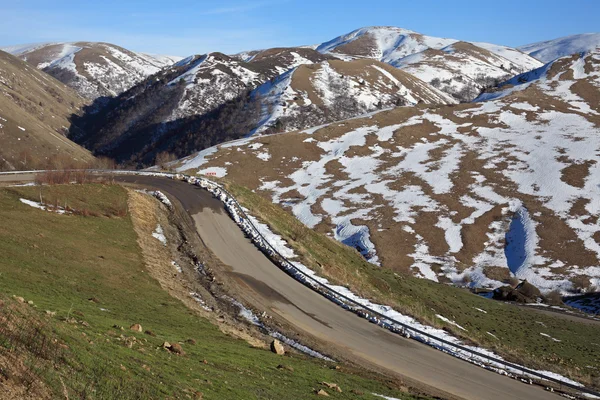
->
[174,52,600,292]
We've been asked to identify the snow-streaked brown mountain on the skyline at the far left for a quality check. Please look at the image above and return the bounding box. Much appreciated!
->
[4,42,180,100]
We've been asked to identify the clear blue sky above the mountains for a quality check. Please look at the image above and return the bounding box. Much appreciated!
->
[0,0,600,56]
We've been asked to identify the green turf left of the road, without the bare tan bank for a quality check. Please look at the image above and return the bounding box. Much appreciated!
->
[0,185,422,399]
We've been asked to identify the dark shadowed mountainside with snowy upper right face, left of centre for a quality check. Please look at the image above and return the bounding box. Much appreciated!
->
[71,53,273,164]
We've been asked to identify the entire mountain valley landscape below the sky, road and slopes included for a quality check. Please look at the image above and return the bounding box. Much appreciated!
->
[0,9,600,400]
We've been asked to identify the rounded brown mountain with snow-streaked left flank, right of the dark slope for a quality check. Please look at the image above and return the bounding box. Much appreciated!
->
[251,59,456,133]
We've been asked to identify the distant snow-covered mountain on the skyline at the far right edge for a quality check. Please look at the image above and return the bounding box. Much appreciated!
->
[519,33,600,63]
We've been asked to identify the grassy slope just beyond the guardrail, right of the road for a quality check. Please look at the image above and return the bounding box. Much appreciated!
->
[227,183,600,386]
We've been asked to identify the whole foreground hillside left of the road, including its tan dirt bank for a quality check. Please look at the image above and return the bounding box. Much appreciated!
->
[0,184,418,400]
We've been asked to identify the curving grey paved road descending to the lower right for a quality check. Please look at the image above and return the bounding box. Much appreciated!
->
[0,176,561,400]
